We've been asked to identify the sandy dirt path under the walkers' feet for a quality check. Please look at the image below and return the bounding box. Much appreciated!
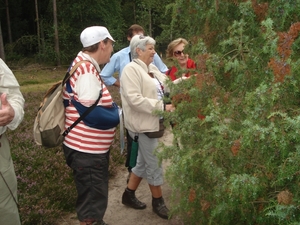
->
[58,130,183,225]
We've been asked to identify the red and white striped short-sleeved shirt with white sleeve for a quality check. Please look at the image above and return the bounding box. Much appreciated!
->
[63,52,115,154]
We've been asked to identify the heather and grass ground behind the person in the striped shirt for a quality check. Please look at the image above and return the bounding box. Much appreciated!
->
[7,68,125,225]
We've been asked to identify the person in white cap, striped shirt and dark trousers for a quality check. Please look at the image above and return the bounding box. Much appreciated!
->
[63,26,116,225]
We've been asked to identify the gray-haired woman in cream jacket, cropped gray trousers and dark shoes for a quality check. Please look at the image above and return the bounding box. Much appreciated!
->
[120,35,175,219]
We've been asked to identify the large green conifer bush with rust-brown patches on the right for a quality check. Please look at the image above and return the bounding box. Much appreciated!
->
[160,0,300,225]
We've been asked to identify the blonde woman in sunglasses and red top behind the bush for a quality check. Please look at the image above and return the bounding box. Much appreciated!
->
[166,38,196,83]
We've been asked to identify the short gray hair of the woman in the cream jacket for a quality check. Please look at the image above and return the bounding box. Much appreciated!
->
[130,35,156,59]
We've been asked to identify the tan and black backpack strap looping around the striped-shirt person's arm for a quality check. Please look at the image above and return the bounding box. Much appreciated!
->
[62,60,103,137]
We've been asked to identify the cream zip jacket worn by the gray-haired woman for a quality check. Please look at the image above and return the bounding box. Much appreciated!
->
[120,59,168,133]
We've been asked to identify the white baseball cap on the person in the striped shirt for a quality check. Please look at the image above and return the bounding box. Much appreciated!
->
[80,26,115,47]
